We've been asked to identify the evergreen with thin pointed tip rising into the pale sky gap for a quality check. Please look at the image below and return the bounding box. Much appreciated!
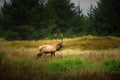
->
[69,1,86,35]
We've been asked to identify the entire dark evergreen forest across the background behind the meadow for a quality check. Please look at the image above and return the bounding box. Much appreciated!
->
[0,0,120,40]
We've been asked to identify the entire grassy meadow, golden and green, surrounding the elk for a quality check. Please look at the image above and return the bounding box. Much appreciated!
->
[0,36,120,80]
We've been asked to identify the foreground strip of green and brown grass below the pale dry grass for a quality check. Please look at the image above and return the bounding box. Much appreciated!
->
[0,57,120,80]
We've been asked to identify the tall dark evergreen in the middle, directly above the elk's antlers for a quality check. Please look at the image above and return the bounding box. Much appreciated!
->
[46,0,75,32]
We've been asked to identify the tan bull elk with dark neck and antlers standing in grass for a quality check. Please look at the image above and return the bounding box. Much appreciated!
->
[36,34,63,59]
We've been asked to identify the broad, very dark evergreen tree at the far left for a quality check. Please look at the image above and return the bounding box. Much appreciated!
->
[0,0,45,39]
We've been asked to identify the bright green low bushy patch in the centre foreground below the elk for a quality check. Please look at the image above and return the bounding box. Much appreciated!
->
[48,58,84,71]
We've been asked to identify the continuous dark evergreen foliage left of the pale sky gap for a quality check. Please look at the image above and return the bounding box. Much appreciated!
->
[0,0,85,40]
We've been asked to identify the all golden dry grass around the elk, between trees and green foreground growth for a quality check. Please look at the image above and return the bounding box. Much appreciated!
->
[0,36,120,60]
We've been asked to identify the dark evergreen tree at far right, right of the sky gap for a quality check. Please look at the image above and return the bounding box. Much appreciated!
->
[88,0,120,36]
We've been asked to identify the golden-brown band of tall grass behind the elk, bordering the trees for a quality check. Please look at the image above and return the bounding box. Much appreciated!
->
[0,36,120,50]
